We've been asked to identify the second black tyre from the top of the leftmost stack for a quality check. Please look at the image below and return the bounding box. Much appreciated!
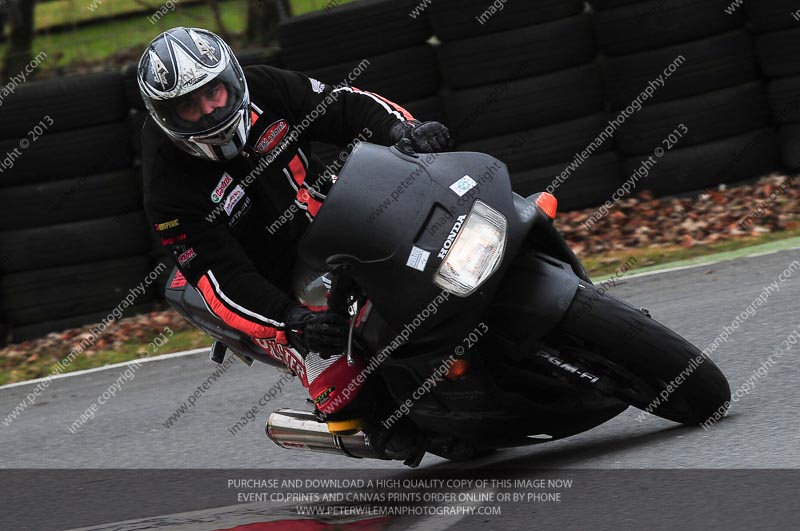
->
[0,122,132,187]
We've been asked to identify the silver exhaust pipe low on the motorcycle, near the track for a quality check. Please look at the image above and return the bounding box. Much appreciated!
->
[265,409,386,459]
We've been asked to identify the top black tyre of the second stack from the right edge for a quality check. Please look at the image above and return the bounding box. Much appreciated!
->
[594,0,746,55]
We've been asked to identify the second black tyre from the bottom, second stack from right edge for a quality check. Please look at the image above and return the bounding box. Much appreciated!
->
[617,83,770,155]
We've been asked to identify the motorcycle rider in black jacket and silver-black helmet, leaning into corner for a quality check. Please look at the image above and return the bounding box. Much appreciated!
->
[137,27,451,430]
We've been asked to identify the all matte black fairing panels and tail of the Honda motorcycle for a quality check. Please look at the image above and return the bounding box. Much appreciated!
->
[161,144,627,455]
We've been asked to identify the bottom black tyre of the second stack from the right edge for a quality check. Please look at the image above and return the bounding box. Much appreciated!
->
[622,129,783,196]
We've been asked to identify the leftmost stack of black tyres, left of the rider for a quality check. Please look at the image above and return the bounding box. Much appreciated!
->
[0,73,160,341]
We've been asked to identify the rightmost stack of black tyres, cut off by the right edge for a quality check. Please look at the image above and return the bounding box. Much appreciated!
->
[747,0,800,172]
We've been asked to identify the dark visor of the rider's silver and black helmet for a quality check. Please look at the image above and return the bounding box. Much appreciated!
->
[152,63,245,137]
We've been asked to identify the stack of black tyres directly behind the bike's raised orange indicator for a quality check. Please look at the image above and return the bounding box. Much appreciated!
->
[431,0,620,209]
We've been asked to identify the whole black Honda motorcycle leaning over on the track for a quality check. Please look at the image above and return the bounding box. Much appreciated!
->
[167,144,730,466]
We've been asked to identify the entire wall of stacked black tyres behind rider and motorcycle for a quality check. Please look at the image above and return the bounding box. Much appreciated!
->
[0,0,800,342]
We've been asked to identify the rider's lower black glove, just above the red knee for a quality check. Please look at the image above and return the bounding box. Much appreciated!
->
[286,306,349,359]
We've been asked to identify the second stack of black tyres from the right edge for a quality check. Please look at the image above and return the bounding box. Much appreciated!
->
[590,0,781,195]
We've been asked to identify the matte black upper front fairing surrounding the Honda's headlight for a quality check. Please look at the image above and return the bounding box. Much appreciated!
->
[299,144,533,342]
